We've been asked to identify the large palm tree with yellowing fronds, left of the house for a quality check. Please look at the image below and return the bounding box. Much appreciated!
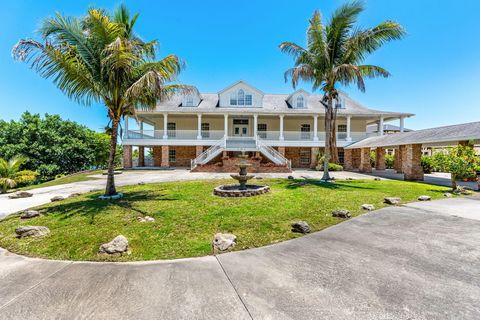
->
[12,5,195,196]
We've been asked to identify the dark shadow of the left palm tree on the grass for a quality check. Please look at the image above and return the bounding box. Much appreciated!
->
[43,191,178,224]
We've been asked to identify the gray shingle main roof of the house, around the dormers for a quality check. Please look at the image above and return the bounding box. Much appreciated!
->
[140,93,413,120]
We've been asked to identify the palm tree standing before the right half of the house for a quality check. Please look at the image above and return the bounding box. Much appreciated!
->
[280,1,405,180]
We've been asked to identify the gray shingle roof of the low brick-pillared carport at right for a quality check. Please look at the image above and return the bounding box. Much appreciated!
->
[346,121,480,149]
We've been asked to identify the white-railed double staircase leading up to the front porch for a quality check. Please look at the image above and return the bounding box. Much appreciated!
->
[191,136,291,170]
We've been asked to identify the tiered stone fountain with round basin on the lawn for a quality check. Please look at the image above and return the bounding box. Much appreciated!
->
[213,152,270,198]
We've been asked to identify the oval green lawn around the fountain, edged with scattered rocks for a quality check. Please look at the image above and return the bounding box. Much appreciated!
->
[0,179,448,261]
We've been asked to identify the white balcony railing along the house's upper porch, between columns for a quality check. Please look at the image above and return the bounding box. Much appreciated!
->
[124,130,376,141]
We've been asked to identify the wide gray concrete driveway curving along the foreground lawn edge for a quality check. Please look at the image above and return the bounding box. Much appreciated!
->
[0,197,480,320]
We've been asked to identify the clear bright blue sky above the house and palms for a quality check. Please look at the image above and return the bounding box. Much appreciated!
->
[0,0,480,130]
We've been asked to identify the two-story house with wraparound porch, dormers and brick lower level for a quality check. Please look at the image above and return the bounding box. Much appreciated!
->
[123,81,412,172]
